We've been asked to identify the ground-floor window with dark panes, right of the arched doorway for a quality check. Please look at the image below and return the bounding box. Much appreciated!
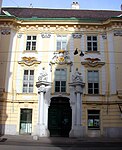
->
[88,110,100,129]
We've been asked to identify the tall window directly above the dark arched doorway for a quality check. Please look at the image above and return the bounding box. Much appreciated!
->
[55,69,67,92]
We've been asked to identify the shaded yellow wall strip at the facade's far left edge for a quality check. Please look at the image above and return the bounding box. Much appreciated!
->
[0,29,14,135]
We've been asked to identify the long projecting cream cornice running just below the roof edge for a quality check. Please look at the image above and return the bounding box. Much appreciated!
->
[0,15,122,28]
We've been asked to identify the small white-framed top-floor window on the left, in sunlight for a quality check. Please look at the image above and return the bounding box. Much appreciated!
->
[26,36,36,50]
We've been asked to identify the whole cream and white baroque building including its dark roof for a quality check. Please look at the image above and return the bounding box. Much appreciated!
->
[0,3,122,137]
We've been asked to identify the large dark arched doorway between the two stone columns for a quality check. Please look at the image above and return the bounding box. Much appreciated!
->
[48,97,72,137]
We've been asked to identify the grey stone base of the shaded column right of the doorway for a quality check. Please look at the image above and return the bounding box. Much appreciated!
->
[69,125,85,137]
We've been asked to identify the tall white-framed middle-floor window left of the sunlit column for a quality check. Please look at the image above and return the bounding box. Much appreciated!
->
[23,70,34,93]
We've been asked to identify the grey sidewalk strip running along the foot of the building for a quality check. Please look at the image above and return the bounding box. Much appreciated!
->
[0,135,122,145]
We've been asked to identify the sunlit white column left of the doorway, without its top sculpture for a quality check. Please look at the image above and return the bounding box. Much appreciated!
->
[33,81,51,139]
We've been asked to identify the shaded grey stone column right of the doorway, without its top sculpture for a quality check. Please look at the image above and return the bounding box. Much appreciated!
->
[69,81,84,137]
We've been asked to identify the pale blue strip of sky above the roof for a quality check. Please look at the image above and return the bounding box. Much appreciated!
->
[2,0,122,10]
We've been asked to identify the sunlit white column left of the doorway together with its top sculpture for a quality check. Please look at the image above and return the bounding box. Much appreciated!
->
[33,72,51,140]
